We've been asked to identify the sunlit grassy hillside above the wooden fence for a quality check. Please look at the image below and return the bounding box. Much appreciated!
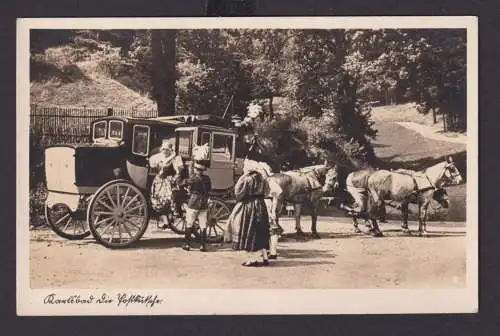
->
[30,46,156,110]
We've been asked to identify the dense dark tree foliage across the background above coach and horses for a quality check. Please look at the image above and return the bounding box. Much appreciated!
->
[33,29,466,166]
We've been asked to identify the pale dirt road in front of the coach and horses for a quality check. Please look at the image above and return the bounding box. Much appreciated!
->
[30,217,466,289]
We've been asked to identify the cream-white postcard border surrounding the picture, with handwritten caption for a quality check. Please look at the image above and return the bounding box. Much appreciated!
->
[16,17,478,315]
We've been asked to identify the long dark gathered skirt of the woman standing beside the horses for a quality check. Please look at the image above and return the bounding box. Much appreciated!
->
[229,198,269,252]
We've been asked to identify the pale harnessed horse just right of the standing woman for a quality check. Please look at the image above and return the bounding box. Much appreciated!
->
[265,161,337,238]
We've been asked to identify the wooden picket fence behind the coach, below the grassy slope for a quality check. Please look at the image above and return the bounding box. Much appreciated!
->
[30,105,158,144]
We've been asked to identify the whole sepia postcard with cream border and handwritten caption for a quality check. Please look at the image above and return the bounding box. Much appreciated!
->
[16,17,479,315]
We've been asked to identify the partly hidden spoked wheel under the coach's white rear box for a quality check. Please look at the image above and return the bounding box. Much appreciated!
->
[45,203,90,240]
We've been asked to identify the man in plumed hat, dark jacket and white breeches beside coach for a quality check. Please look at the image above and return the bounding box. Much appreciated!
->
[182,161,212,252]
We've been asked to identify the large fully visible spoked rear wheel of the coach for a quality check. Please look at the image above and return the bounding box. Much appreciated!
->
[87,180,149,248]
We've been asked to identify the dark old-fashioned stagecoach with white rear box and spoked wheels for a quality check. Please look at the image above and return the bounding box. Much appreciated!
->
[45,115,242,248]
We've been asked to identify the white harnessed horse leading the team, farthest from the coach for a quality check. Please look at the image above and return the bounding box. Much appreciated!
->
[367,157,463,235]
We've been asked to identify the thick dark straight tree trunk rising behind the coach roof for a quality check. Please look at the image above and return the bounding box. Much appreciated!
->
[151,29,176,116]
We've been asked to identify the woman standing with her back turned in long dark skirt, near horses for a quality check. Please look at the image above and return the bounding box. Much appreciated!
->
[229,160,270,267]
